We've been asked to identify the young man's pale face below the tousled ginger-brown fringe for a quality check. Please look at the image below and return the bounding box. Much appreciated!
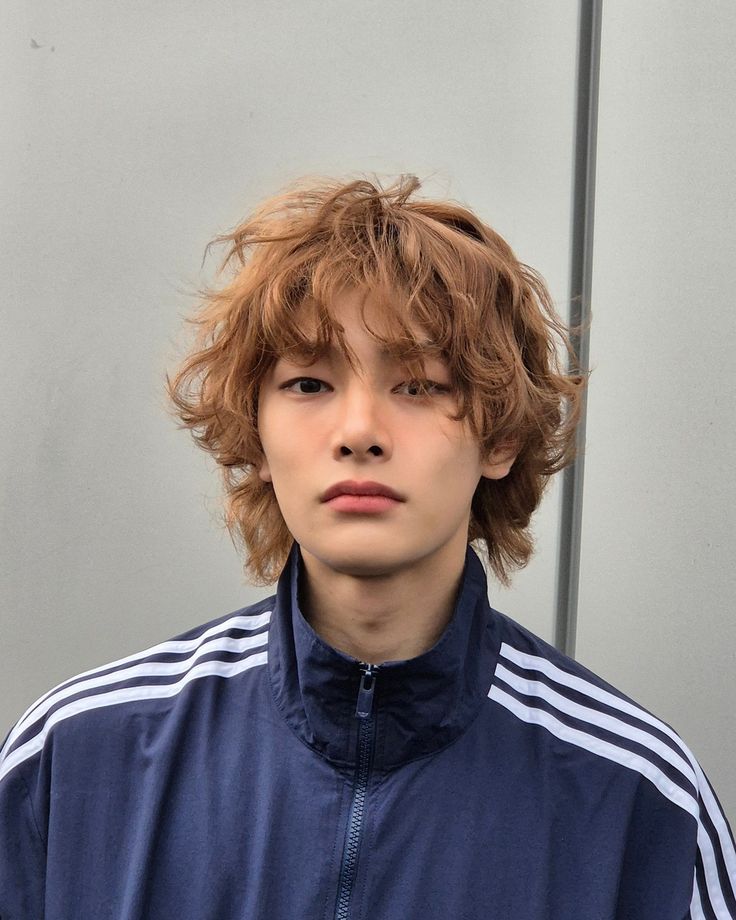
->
[258,290,513,577]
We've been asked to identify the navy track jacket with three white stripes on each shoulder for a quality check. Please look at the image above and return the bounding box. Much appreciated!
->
[0,544,736,920]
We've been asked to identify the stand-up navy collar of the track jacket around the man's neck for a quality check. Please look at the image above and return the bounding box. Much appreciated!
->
[268,542,500,770]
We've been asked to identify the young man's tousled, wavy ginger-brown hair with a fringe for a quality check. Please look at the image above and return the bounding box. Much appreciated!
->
[166,175,585,586]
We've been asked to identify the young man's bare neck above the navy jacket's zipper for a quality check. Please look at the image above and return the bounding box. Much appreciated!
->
[299,549,465,664]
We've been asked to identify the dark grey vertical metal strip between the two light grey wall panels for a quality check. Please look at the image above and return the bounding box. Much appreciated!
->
[555,0,603,655]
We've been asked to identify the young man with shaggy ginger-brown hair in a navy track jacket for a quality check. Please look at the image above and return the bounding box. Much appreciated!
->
[0,178,736,920]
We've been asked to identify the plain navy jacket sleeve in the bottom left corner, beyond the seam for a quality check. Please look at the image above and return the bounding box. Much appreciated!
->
[0,760,46,920]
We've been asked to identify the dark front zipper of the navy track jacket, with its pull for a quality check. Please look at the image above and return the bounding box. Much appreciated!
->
[335,664,378,920]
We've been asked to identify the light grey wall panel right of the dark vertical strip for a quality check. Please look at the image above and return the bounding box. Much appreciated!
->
[576,0,736,821]
